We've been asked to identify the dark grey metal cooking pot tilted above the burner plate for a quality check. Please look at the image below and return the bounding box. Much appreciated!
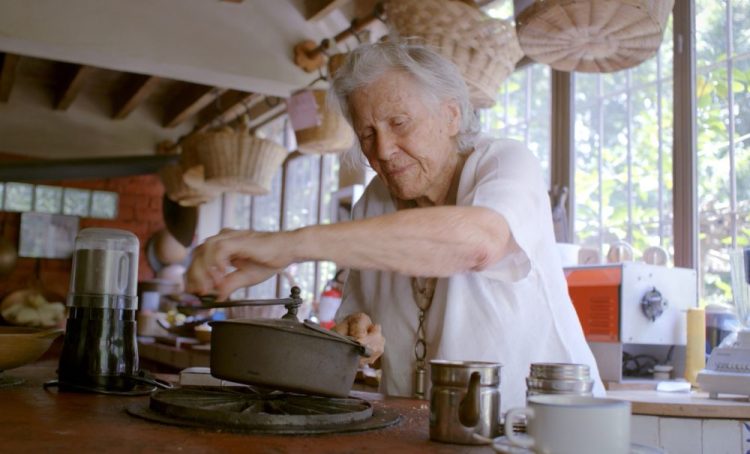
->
[211,319,370,397]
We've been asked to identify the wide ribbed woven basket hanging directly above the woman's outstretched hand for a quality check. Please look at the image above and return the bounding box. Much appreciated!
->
[182,128,287,195]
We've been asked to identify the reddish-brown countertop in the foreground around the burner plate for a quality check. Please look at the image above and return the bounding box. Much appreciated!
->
[0,360,492,454]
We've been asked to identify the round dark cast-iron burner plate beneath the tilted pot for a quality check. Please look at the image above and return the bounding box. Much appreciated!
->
[126,386,401,435]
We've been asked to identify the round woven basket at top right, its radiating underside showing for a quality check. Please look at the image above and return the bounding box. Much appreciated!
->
[513,0,674,73]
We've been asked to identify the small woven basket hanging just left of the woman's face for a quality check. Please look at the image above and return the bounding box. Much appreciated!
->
[294,90,354,154]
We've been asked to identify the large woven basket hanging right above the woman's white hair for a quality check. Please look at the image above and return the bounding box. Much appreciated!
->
[385,0,523,108]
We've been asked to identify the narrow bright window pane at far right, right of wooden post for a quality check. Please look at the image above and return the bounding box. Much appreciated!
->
[695,0,750,303]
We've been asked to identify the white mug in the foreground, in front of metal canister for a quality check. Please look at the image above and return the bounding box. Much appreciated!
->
[505,394,630,454]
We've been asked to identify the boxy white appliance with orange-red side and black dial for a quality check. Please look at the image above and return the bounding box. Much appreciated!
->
[565,262,698,382]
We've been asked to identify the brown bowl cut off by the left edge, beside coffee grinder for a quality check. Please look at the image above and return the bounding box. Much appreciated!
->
[0,326,63,371]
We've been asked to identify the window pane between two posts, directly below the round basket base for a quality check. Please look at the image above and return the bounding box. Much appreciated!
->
[573,15,674,260]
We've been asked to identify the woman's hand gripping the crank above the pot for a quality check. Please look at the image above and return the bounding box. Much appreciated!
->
[186,229,292,301]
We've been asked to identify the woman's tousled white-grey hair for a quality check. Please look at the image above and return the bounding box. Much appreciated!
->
[327,37,479,160]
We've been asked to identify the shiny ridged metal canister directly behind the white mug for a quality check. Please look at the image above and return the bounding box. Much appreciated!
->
[526,363,594,397]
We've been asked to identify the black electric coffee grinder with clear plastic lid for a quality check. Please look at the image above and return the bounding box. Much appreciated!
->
[51,228,148,395]
